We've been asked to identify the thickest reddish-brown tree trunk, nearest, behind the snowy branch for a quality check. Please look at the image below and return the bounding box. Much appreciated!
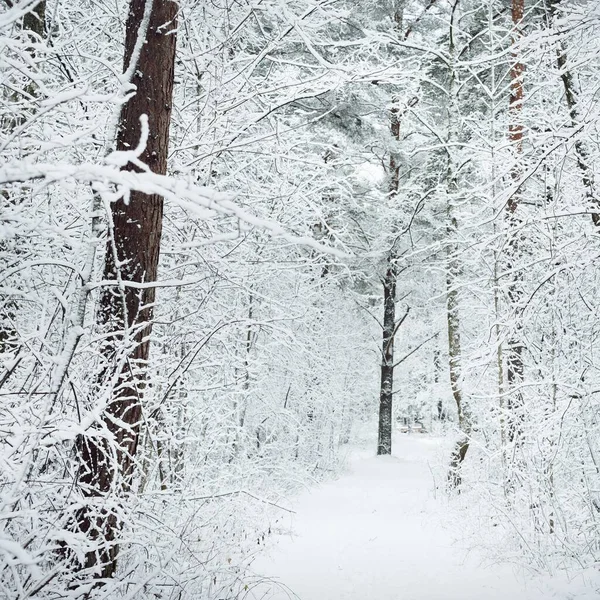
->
[78,0,178,577]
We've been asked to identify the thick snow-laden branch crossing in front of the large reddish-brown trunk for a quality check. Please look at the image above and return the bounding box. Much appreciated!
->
[0,162,350,258]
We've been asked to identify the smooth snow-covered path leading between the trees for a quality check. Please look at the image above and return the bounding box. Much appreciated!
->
[249,435,598,600]
